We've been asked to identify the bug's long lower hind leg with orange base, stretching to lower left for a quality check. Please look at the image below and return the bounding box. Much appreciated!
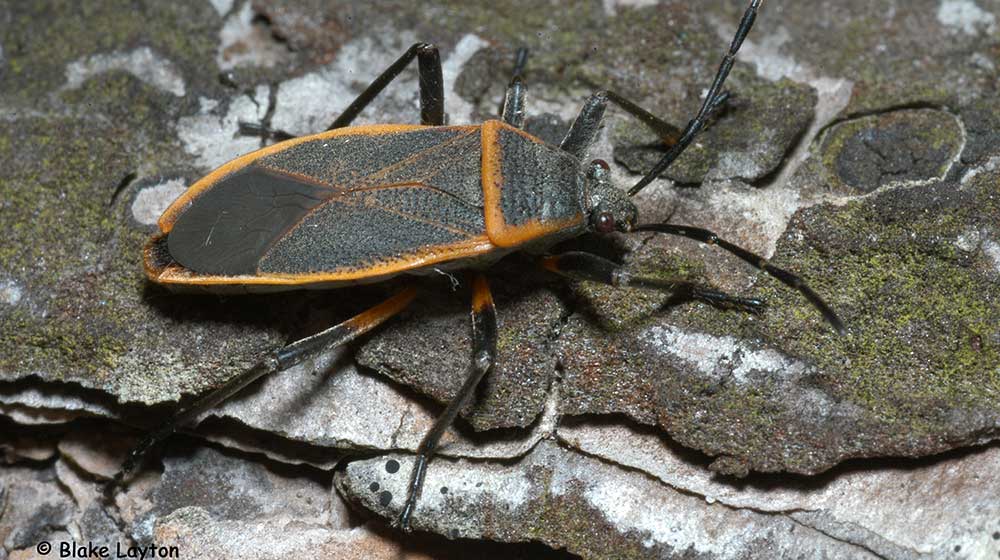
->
[105,288,416,500]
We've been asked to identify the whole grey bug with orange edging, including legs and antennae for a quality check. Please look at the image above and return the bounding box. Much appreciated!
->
[113,0,844,530]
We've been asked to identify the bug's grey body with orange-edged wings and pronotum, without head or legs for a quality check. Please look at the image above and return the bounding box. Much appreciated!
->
[145,120,592,291]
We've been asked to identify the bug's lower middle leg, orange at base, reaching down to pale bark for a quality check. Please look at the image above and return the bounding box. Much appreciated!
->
[398,273,497,531]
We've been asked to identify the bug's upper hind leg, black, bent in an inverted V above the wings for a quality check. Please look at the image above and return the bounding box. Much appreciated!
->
[327,43,444,130]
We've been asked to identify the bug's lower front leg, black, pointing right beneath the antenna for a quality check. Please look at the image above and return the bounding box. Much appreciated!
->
[542,251,764,313]
